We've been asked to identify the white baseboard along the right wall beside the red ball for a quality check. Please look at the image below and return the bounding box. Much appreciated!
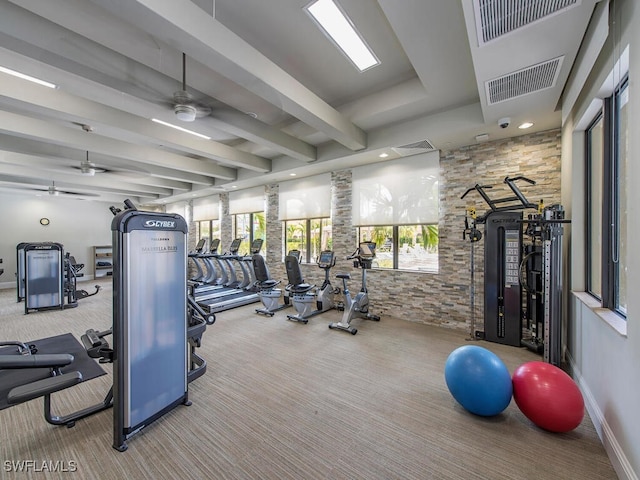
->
[567,352,638,480]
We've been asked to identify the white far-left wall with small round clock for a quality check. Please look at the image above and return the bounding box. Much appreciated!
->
[0,194,113,288]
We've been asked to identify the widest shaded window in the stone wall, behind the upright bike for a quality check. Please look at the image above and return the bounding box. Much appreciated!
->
[352,152,440,272]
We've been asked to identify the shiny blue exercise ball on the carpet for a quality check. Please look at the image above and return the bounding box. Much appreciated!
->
[444,345,513,417]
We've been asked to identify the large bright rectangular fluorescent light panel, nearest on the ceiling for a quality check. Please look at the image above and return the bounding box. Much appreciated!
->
[305,0,380,72]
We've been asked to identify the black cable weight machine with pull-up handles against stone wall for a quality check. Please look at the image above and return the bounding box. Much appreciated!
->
[461,176,569,365]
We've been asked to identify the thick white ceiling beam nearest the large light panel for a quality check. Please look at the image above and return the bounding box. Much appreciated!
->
[80,0,367,150]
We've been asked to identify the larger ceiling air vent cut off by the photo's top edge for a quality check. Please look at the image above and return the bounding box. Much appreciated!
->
[473,0,581,46]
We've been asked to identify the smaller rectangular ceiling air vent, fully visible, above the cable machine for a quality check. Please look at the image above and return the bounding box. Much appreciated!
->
[485,56,564,105]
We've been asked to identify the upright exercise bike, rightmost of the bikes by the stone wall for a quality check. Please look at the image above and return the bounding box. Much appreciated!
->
[329,242,380,335]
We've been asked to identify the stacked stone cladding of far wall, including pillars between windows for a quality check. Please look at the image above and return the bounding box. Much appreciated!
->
[194,130,561,329]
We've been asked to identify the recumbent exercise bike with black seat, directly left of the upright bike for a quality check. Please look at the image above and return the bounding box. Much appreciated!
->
[284,250,340,323]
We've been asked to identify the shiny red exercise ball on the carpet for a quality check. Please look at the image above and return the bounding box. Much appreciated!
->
[511,362,584,432]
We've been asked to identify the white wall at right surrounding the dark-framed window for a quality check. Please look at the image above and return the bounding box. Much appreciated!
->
[562,0,640,479]
